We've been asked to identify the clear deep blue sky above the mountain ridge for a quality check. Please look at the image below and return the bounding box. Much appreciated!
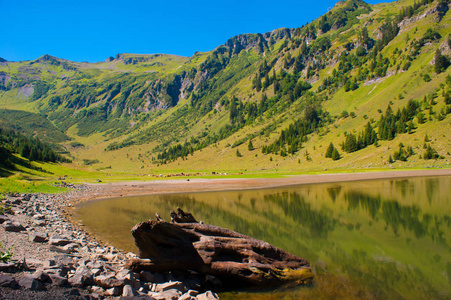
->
[0,0,390,62]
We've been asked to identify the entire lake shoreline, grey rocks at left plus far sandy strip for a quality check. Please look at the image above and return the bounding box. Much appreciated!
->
[0,169,451,299]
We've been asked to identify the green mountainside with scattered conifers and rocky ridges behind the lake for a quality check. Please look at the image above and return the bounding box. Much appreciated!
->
[0,0,451,174]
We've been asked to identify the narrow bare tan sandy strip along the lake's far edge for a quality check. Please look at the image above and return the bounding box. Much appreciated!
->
[72,169,451,204]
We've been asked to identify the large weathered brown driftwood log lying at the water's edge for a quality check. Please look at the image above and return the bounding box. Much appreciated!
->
[126,208,313,286]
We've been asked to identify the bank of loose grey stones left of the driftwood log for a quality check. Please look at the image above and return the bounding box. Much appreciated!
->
[0,186,219,300]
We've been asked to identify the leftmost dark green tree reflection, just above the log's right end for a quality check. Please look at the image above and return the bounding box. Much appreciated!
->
[264,192,336,237]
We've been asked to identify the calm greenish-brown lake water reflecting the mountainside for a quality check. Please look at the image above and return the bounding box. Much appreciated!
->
[76,176,451,299]
